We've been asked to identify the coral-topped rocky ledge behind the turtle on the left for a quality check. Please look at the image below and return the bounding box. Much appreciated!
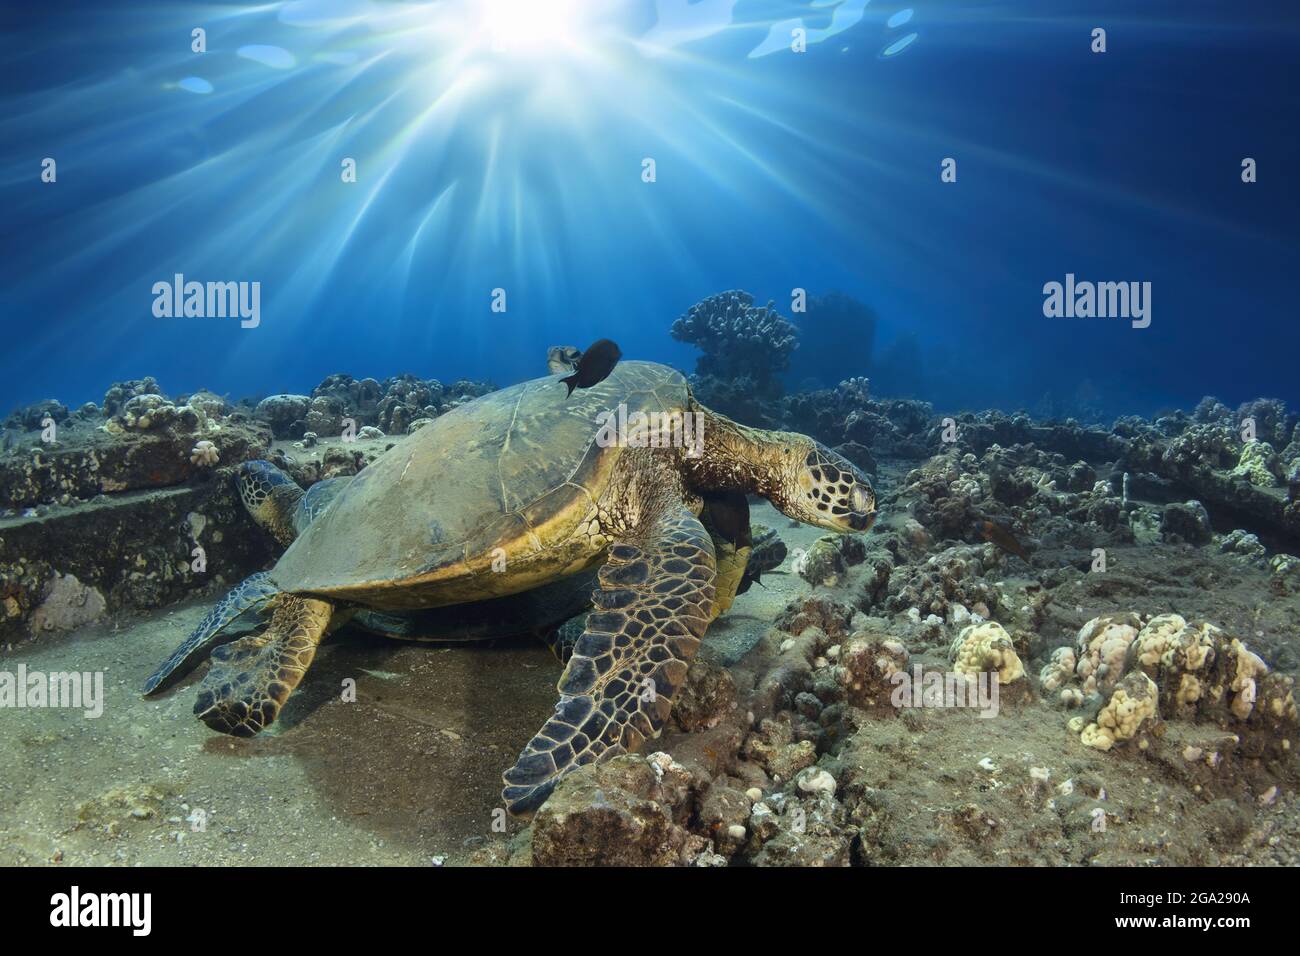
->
[0,375,494,643]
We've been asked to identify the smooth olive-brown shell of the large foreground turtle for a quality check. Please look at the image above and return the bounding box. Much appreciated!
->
[272,362,690,607]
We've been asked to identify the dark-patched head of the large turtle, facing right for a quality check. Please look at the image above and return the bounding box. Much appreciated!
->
[767,434,876,533]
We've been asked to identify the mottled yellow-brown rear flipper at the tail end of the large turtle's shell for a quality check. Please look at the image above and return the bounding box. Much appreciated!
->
[194,594,334,737]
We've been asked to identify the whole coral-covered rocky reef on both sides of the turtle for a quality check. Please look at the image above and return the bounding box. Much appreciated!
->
[0,293,1300,866]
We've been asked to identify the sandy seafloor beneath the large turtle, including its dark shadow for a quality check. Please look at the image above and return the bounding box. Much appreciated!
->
[0,509,820,866]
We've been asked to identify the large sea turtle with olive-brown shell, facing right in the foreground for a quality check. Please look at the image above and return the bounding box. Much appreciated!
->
[139,362,875,813]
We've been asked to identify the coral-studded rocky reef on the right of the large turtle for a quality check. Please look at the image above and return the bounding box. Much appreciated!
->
[476,380,1300,866]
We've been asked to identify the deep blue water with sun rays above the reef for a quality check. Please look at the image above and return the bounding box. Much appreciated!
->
[0,0,1300,412]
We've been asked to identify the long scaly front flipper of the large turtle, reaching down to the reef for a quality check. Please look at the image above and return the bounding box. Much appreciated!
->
[502,503,716,813]
